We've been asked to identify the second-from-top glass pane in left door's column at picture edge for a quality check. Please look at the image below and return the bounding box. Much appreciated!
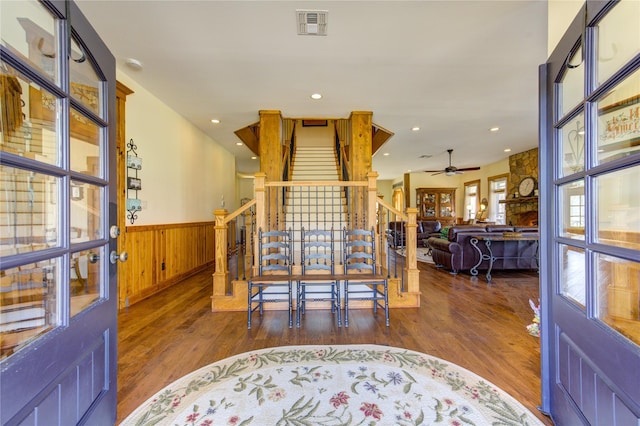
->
[0,62,59,164]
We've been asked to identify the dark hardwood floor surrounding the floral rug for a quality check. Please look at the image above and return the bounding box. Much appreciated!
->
[118,263,552,425]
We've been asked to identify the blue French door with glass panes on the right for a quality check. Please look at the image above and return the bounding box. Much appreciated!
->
[540,0,640,426]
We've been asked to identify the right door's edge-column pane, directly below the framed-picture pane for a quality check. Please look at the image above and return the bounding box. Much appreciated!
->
[595,166,640,250]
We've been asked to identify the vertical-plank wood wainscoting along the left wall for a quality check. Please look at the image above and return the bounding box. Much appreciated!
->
[118,222,215,309]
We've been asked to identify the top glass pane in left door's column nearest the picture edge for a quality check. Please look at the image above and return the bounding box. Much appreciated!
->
[0,0,58,82]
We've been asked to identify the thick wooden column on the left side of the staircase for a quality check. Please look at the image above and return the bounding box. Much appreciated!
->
[259,110,282,229]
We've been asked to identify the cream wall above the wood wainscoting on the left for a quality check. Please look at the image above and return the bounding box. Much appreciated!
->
[116,70,239,226]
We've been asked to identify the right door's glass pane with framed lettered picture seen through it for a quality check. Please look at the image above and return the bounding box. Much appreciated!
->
[598,70,640,164]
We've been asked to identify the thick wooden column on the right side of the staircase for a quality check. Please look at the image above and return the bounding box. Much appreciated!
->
[349,111,375,228]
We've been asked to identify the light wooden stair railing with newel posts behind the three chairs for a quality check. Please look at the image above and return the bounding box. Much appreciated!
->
[213,172,419,310]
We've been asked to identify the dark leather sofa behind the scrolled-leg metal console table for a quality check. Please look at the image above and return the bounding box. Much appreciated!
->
[428,225,538,274]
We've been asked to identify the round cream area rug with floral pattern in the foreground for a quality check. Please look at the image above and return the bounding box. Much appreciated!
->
[122,345,542,426]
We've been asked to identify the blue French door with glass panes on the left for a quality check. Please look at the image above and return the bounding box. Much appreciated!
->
[0,0,118,425]
